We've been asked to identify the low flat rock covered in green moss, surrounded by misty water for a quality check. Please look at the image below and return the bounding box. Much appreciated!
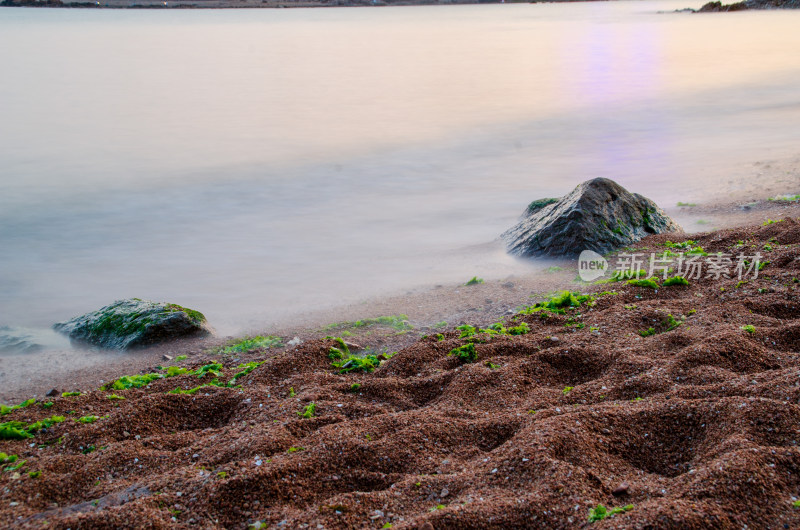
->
[53,298,212,350]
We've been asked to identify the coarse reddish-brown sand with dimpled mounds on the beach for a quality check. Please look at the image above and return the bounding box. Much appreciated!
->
[0,213,800,528]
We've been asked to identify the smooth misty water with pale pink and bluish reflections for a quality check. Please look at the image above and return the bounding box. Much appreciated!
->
[0,0,800,333]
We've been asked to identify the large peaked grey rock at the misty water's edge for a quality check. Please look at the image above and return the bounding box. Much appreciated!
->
[501,178,681,257]
